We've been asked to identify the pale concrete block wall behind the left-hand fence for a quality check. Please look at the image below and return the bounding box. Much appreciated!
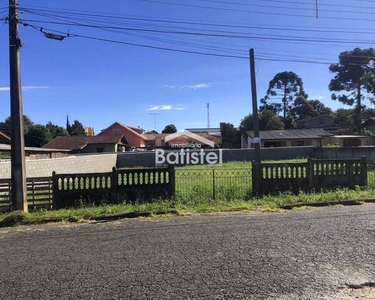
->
[0,153,117,179]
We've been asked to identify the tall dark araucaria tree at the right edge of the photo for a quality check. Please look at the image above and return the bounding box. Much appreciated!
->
[329,48,375,132]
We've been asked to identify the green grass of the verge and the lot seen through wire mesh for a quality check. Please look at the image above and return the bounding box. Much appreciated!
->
[0,159,375,227]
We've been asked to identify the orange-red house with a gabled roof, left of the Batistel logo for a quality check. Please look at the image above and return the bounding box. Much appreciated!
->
[97,122,148,148]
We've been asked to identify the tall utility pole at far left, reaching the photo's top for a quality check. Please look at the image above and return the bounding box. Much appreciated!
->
[8,0,28,212]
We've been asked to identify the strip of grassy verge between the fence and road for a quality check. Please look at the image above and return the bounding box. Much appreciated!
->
[0,189,375,227]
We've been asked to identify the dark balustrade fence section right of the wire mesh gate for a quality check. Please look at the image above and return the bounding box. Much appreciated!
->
[252,158,367,196]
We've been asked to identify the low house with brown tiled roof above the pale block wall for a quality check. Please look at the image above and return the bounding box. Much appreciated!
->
[43,135,130,153]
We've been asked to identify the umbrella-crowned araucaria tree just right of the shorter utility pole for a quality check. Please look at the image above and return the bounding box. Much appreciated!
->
[261,72,307,129]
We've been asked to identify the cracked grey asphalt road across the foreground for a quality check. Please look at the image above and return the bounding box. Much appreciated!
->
[0,205,375,299]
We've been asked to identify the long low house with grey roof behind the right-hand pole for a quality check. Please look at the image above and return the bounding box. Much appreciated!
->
[241,129,333,148]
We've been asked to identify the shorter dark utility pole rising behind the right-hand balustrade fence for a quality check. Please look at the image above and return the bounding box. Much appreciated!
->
[250,49,261,164]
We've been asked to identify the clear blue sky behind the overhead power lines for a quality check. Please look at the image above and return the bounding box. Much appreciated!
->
[0,0,375,132]
